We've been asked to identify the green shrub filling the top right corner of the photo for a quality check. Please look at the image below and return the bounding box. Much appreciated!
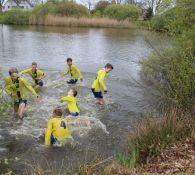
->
[147,0,195,36]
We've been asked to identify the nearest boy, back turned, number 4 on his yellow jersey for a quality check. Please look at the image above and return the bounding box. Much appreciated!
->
[45,108,71,146]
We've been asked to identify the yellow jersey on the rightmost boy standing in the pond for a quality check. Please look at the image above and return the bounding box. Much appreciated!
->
[92,69,107,92]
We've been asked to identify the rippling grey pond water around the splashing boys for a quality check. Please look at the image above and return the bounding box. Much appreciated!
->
[0,25,169,172]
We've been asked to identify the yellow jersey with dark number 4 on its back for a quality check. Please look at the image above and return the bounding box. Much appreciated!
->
[45,117,71,145]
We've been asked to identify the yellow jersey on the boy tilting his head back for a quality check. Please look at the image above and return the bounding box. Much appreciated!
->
[60,96,79,113]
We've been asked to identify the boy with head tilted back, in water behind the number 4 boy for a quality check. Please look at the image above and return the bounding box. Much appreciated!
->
[60,89,79,117]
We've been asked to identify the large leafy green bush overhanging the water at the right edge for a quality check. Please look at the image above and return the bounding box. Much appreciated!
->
[141,30,195,110]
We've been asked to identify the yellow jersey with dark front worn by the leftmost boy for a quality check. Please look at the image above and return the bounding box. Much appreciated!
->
[5,76,38,102]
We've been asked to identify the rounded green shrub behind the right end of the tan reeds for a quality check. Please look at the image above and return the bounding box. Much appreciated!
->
[104,4,140,20]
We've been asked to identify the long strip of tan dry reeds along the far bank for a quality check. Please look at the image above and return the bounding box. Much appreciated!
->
[29,15,133,28]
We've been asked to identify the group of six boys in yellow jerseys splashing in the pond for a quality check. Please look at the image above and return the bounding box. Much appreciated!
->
[5,58,113,145]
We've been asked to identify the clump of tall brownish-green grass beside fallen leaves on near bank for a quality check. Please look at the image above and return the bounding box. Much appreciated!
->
[128,109,195,163]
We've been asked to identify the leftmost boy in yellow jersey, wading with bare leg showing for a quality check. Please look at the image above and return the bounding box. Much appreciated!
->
[5,68,39,119]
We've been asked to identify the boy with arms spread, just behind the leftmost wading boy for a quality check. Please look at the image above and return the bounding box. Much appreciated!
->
[20,62,46,87]
